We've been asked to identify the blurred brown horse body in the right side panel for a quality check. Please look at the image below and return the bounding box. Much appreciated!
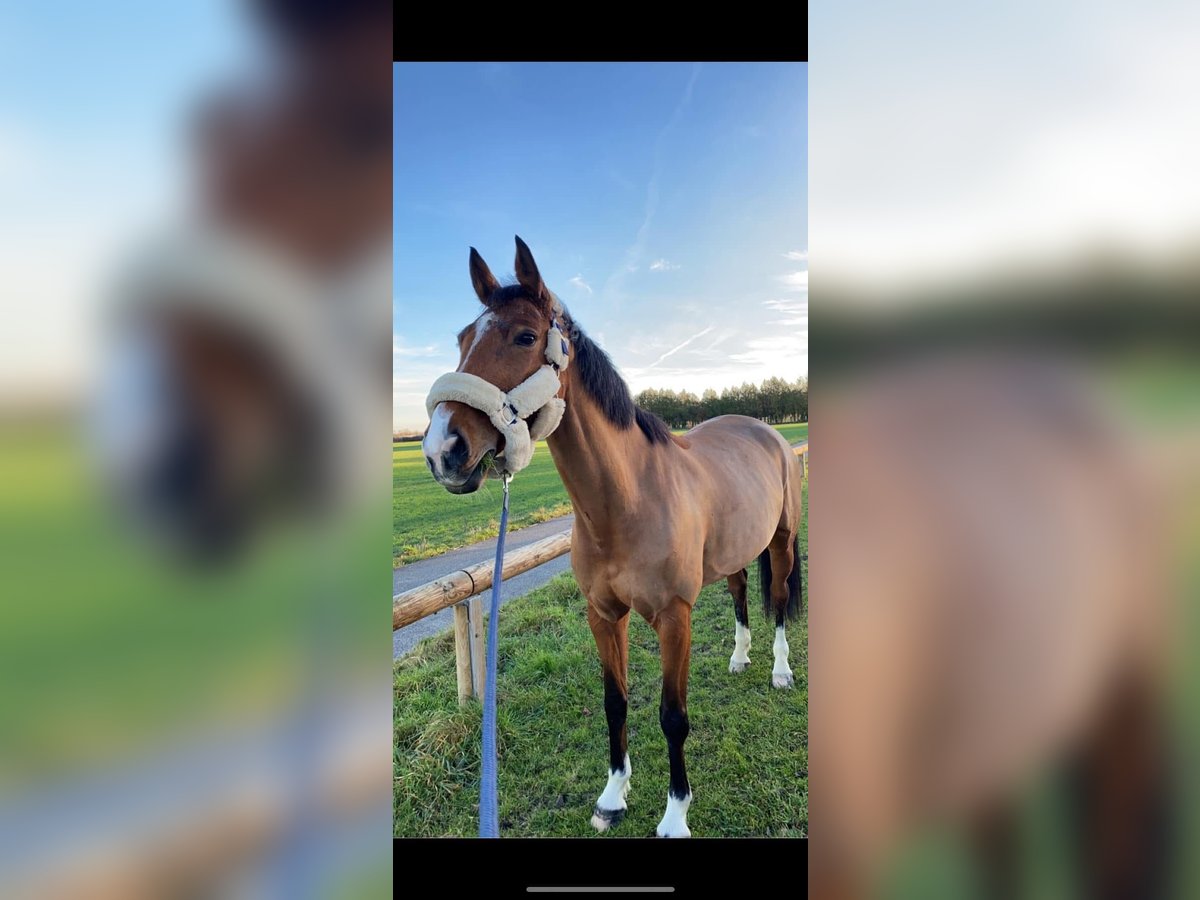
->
[809,348,1176,900]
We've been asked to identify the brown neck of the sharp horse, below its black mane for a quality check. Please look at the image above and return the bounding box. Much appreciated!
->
[547,388,648,540]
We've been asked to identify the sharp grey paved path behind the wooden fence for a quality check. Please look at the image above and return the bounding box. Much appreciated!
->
[391,515,575,659]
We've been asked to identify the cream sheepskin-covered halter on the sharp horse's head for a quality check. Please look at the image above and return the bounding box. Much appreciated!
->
[425,316,570,475]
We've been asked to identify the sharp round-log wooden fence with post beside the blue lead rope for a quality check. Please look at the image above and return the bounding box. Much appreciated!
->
[391,440,809,703]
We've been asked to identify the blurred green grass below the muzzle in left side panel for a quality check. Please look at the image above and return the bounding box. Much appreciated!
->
[0,422,386,791]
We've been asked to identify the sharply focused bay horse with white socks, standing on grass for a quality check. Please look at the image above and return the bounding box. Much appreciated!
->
[424,238,802,838]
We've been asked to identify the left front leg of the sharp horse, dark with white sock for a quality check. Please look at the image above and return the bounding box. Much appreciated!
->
[588,604,630,832]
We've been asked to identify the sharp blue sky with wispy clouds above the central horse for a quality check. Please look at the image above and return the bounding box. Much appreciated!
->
[392,64,808,428]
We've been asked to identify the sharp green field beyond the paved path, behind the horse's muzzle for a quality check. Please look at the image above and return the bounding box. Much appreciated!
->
[391,422,809,566]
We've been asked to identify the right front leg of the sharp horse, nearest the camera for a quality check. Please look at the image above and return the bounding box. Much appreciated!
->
[653,599,691,838]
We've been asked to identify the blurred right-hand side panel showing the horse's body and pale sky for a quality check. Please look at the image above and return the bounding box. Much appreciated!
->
[809,2,1200,898]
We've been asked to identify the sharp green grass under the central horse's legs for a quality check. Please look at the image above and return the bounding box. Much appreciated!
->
[394,482,809,838]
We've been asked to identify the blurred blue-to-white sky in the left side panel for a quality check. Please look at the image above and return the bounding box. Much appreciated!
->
[0,0,253,397]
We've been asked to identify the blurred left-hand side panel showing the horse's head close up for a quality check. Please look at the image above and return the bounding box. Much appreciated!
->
[0,0,391,898]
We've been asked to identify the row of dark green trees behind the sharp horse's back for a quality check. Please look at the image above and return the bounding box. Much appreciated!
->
[634,378,809,428]
